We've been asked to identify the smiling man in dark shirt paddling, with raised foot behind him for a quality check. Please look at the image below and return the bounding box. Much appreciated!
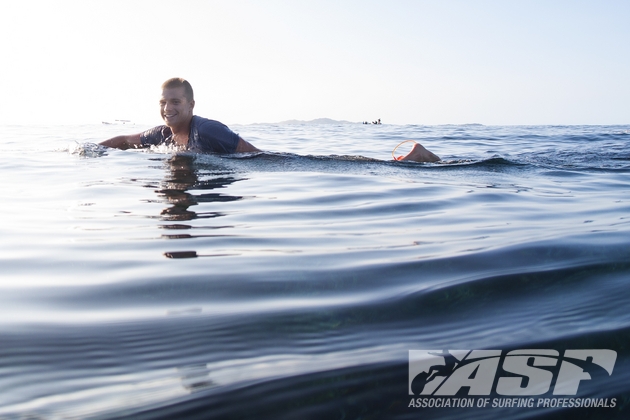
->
[101,78,440,162]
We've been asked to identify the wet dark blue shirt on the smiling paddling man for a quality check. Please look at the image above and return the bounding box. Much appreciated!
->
[140,115,240,153]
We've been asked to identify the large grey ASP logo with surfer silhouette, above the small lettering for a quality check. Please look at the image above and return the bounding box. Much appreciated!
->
[409,349,617,396]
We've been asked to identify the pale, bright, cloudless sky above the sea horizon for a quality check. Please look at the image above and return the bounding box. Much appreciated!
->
[0,0,630,125]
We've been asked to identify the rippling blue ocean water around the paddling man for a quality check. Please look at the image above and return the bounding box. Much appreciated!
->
[0,120,630,420]
